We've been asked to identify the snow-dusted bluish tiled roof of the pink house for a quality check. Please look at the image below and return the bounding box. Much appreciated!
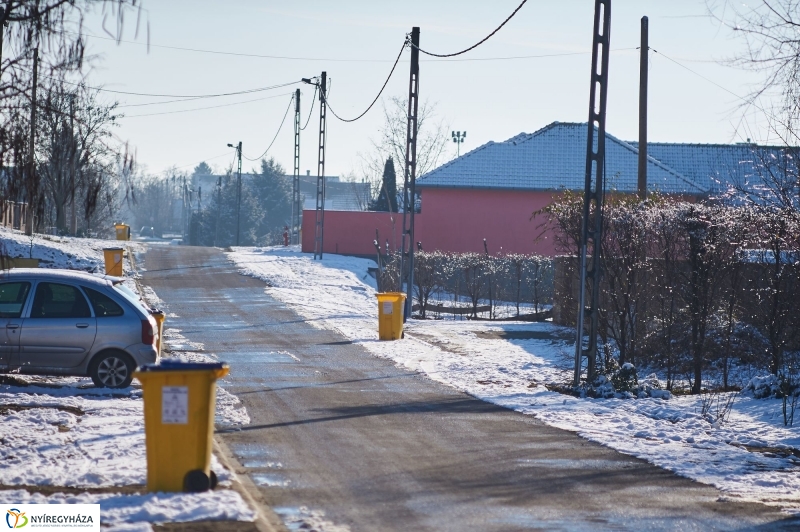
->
[417,122,764,195]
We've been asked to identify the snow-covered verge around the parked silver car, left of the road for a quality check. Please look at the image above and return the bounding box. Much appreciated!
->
[0,229,255,531]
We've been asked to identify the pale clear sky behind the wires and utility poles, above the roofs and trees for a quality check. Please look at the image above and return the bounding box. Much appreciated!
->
[79,0,769,180]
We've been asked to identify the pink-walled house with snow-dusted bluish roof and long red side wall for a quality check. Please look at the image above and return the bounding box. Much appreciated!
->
[303,122,792,255]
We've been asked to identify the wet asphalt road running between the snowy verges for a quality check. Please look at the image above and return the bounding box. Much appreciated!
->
[144,245,800,532]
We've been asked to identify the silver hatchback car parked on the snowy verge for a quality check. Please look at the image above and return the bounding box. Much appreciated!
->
[0,269,158,388]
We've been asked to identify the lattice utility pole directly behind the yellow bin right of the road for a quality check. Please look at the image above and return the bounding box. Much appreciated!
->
[400,26,419,321]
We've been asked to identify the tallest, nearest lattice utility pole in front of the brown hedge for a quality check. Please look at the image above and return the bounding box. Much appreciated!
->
[573,0,611,386]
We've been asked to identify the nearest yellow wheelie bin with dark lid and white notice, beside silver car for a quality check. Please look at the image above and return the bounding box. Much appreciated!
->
[133,360,229,492]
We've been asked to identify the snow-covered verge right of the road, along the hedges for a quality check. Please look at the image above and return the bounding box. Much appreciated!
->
[229,246,800,513]
